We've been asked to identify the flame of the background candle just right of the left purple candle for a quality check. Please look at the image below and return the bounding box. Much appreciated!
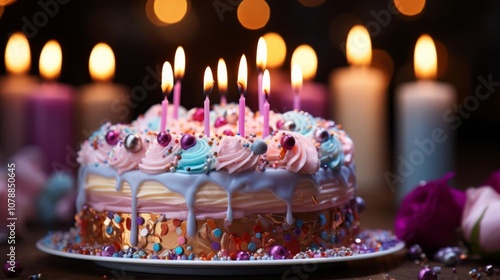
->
[89,43,115,81]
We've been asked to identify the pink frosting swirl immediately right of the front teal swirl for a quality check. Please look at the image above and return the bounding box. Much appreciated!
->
[215,136,260,174]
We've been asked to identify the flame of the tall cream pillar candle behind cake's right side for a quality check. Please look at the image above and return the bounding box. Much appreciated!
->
[346,25,372,66]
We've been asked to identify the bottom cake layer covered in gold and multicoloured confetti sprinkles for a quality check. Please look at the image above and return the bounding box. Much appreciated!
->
[76,203,359,259]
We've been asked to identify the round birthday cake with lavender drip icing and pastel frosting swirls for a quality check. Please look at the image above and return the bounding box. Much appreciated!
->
[75,104,361,260]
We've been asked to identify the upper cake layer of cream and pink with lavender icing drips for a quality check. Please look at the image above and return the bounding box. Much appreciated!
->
[77,165,355,244]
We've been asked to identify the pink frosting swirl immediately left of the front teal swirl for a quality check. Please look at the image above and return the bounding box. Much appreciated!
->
[139,134,182,174]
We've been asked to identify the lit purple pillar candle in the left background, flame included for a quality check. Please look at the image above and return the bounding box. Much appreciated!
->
[26,40,76,172]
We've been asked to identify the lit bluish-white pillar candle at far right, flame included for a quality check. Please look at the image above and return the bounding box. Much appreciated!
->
[392,35,455,202]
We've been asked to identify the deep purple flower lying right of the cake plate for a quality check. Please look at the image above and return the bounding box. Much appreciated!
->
[395,173,466,251]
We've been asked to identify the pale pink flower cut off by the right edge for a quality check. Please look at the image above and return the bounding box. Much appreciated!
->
[461,186,500,258]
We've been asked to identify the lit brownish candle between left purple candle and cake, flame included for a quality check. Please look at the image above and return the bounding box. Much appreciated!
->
[76,43,131,141]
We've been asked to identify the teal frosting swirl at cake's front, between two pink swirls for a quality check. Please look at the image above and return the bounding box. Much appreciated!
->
[176,138,215,174]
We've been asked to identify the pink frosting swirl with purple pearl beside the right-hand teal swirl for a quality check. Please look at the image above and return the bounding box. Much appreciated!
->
[267,131,319,174]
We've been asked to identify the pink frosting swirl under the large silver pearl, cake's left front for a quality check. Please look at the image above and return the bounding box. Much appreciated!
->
[108,136,149,174]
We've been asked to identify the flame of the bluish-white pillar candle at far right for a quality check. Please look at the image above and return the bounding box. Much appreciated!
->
[413,34,437,79]
